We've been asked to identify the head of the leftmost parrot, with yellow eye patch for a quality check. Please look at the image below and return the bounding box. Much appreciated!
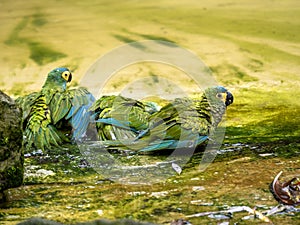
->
[43,67,72,90]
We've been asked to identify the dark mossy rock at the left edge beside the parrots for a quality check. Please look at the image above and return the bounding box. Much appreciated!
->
[0,91,24,201]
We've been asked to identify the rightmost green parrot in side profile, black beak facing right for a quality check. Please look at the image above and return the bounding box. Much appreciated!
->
[136,86,233,152]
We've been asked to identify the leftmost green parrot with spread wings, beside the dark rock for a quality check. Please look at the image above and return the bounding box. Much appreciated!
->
[16,68,95,150]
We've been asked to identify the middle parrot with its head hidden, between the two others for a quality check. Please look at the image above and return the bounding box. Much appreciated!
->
[90,95,157,141]
